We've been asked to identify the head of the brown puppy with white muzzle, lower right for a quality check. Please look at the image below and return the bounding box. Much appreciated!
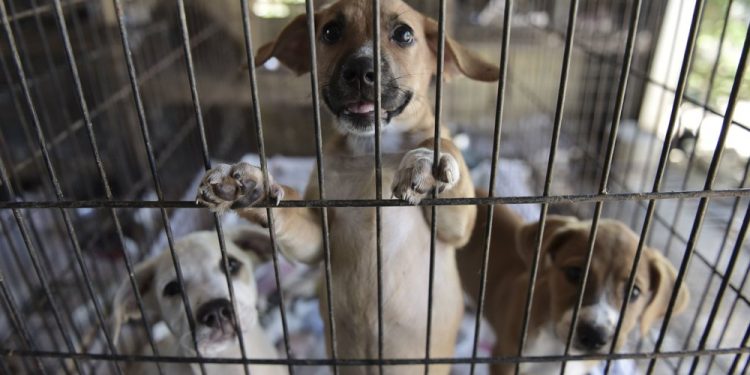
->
[518,216,688,353]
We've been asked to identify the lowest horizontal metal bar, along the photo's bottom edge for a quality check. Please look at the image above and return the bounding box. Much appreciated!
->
[0,347,750,366]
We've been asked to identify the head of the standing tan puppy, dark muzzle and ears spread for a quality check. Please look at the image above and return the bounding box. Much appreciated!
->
[255,0,500,135]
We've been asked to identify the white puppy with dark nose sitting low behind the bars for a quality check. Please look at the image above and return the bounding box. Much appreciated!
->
[113,227,287,375]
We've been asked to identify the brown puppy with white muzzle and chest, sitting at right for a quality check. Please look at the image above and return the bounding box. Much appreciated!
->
[464,205,688,374]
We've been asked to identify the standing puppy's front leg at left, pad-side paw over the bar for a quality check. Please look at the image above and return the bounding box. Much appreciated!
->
[196,163,322,263]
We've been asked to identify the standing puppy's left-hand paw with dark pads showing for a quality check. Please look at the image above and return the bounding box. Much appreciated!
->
[195,162,284,212]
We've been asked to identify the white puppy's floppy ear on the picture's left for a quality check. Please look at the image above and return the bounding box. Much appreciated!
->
[112,257,160,343]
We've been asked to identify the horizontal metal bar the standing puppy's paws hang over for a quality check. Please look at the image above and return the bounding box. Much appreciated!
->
[0,188,750,210]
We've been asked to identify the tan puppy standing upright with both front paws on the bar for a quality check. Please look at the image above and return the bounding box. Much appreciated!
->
[198,0,499,374]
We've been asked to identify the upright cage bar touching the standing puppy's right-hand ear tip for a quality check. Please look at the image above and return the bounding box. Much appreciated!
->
[469,0,513,375]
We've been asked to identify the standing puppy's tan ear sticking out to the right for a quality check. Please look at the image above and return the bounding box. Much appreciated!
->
[424,17,500,82]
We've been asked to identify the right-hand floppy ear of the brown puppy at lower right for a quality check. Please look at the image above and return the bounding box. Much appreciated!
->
[641,248,690,335]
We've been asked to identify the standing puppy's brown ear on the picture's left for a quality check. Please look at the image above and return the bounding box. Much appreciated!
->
[255,14,310,75]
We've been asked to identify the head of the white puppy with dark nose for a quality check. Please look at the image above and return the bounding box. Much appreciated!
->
[113,227,271,356]
